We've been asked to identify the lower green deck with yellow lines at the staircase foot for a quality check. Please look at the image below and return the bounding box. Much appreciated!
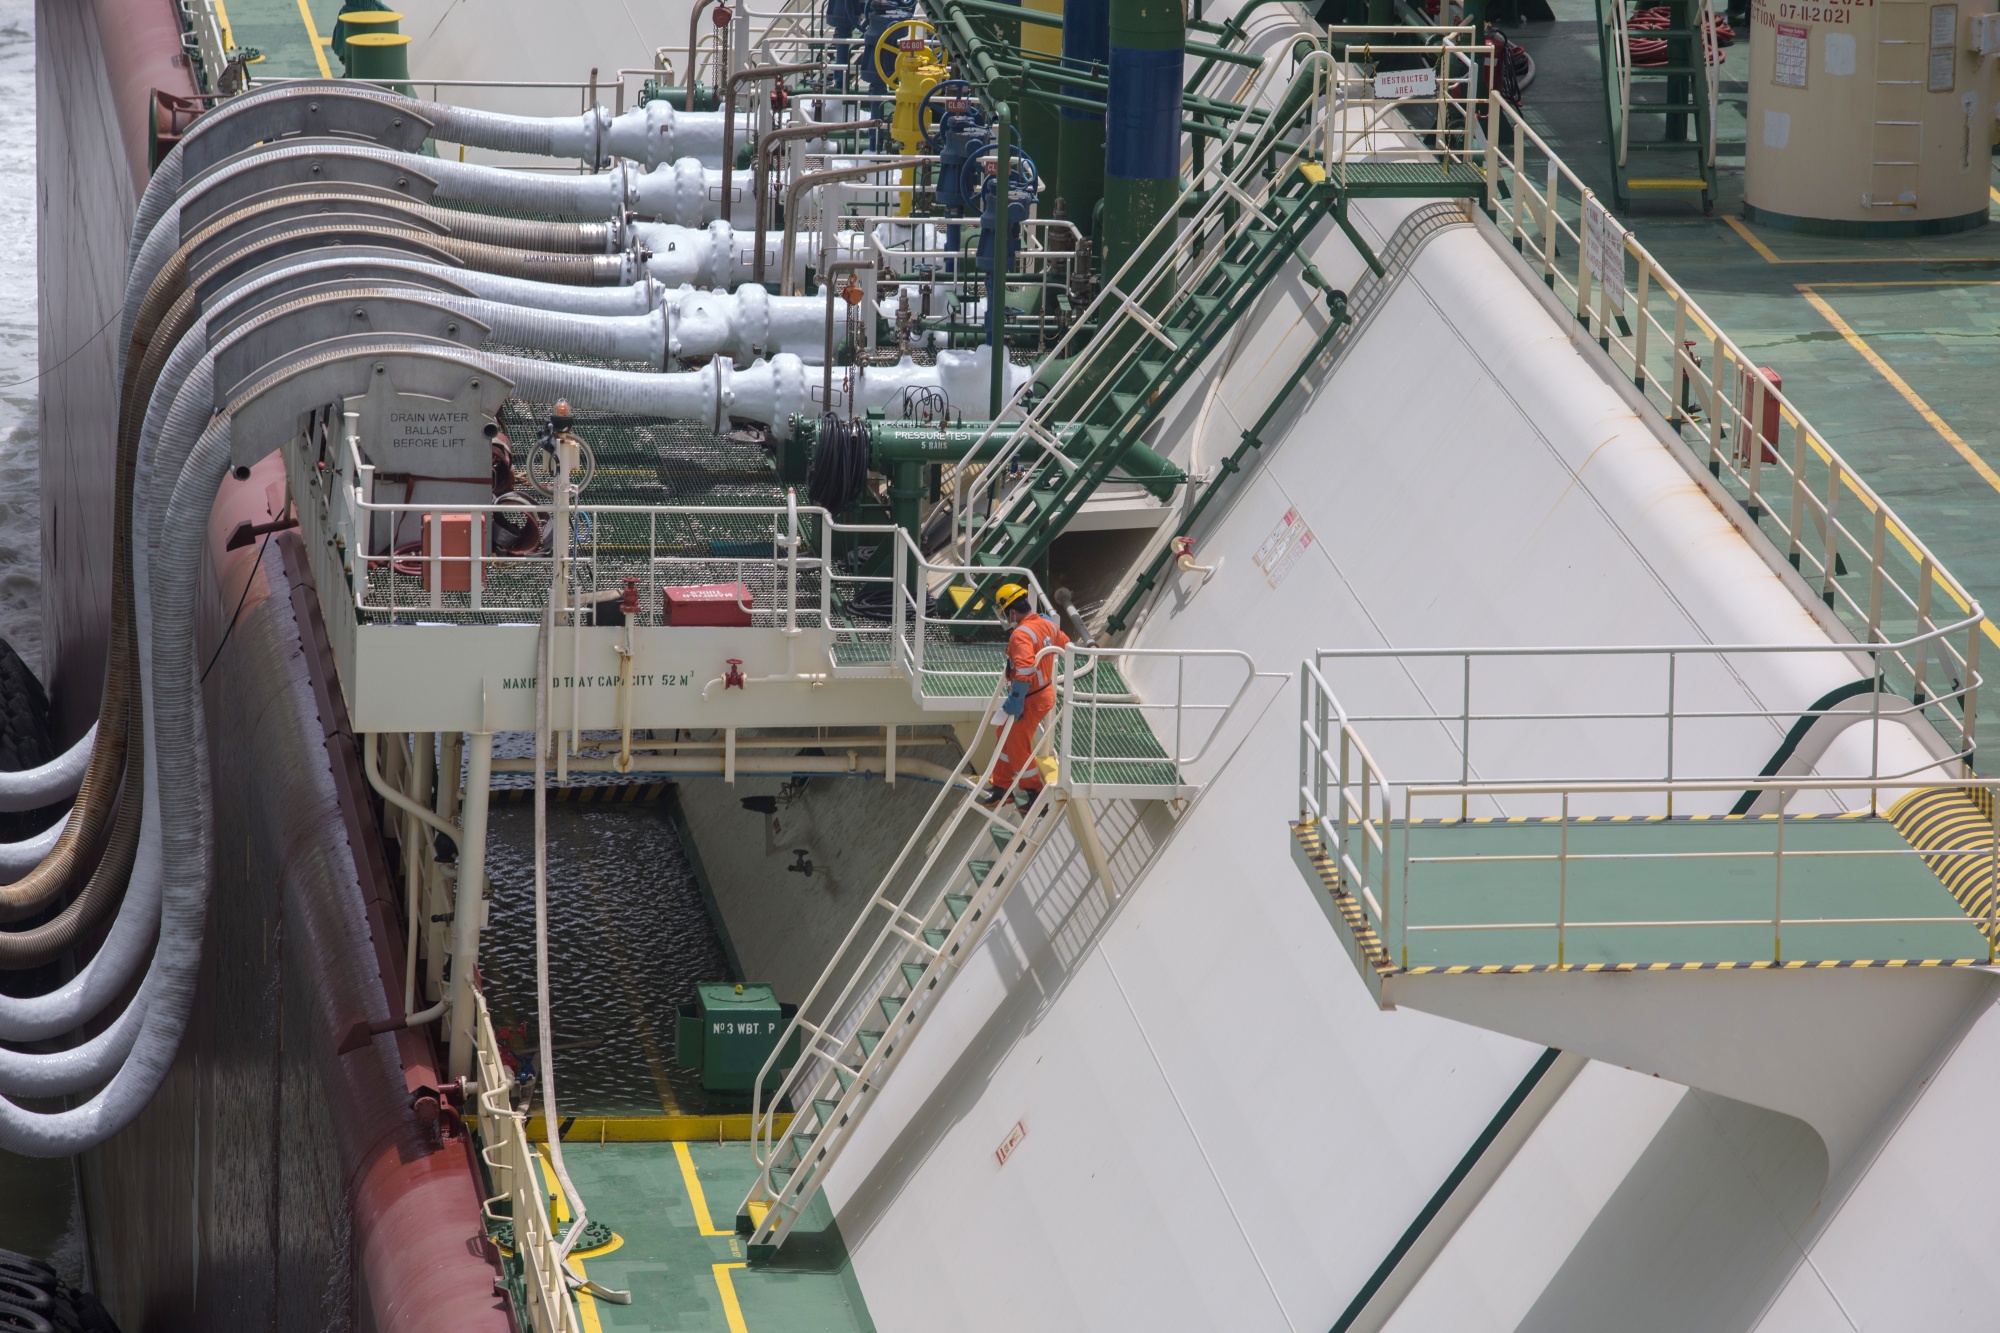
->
[544,1143,874,1333]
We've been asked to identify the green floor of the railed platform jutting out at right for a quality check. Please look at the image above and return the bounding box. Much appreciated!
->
[1386,815,1986,969]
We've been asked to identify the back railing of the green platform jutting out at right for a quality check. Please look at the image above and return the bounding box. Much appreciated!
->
[1312,614,1980,817]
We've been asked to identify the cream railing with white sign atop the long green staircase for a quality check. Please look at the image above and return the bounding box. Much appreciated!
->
[1320,26,1490,188]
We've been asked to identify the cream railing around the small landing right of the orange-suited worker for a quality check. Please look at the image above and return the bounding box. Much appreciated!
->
[1052,644,1284,797]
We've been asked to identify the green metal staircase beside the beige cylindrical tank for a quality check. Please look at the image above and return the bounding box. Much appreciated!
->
[1598,0,1720,210]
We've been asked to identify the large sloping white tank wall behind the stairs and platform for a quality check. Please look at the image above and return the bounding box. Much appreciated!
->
[828,13,1968,1331]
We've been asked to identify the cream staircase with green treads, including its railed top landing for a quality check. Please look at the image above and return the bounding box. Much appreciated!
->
[736,646,1258,1261]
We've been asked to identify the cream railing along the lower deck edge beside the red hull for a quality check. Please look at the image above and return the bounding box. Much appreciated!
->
[472,987,582,1333]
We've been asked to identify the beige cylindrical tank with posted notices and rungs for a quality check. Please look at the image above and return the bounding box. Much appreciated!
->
[1744,0,2000,236]
